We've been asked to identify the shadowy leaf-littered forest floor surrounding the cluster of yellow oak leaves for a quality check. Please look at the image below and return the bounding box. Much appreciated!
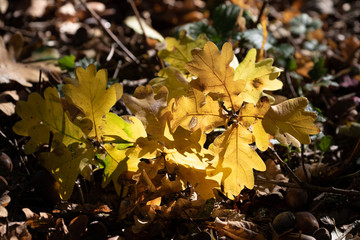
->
[0,0,360,240]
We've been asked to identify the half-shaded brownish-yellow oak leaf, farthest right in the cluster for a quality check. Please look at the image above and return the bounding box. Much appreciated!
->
[262,97,320,147]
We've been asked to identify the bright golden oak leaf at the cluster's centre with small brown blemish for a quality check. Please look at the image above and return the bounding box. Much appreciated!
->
[169,88,225,133]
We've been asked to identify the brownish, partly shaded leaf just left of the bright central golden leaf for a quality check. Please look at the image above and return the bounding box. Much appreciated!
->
[123,85,168,135]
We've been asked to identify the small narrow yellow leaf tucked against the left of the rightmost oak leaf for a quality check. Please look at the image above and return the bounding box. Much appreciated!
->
[239,97,270,151]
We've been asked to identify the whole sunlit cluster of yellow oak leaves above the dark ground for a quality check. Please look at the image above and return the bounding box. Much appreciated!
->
[14,33,319,202]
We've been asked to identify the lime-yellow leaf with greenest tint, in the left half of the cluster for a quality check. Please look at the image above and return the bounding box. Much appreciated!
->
[102,113,146,194]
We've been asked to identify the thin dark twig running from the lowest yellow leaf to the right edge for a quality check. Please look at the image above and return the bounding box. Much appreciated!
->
[255,177,360,196]
